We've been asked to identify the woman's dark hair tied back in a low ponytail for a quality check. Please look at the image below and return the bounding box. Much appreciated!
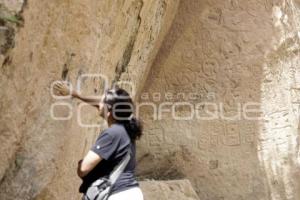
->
[104,87,143,141]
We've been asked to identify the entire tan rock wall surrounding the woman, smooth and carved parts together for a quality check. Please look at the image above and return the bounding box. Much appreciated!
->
[0,0,300,200]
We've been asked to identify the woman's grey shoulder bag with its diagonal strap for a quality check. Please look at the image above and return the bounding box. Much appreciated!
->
[82,150,131,200]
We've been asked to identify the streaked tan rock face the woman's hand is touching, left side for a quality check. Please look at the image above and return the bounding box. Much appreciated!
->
[0,0,178,200]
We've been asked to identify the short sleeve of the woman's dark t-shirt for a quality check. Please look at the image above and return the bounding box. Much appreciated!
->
[91,132,118,160]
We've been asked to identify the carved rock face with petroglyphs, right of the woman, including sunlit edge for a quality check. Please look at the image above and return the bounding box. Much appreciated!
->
[139,0,300,200]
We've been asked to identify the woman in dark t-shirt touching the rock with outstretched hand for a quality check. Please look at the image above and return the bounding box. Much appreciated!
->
[54,82,143,200]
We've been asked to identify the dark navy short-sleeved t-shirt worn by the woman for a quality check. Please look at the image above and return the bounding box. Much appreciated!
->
[79,123,139,194]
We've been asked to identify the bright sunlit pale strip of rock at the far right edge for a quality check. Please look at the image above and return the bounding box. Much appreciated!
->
[258,1,300,199]
